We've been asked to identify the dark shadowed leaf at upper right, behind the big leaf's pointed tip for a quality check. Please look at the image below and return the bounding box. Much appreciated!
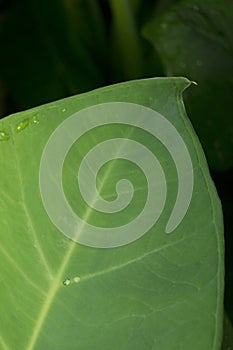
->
[144,0,233,170]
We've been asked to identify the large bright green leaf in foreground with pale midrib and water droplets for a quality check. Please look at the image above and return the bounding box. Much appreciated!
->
[0,78,223,350]
